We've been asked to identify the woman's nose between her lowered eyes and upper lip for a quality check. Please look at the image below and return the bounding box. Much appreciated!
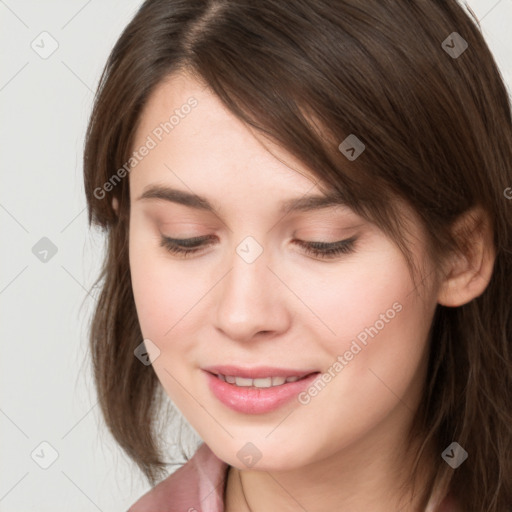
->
[216,237,292,342]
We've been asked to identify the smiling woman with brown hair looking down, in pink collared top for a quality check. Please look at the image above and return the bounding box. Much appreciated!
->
[84,0,512,512]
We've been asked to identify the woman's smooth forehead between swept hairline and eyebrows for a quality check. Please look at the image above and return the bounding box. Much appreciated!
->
[130,74,336,206]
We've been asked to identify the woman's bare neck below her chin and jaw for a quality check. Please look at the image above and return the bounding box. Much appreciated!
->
[225,404,436,512]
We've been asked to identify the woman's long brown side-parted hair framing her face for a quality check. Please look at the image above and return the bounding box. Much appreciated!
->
[84,0,512,512]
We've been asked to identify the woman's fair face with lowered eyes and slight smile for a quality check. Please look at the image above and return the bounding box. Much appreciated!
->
[129,71,436,471]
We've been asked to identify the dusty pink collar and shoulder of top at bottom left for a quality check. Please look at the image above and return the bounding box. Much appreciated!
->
[128,443,228,512]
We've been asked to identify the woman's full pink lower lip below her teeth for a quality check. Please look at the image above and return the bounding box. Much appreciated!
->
[205,372,320,414]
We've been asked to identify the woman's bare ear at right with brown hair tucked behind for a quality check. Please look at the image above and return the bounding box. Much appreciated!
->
[437,206,496,307]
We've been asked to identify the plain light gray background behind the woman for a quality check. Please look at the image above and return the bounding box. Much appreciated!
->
[0,0,512,512]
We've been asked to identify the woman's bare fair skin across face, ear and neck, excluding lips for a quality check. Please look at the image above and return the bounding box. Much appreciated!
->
[125,70,493,512]
